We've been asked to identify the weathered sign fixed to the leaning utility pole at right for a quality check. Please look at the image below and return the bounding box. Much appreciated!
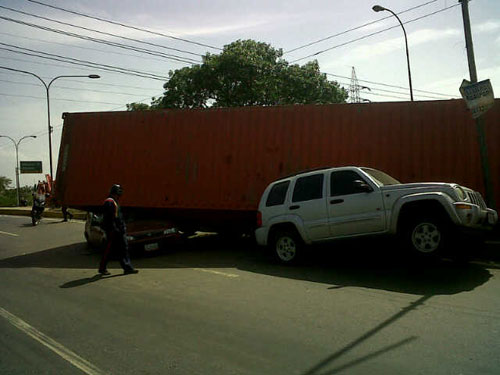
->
[460,79,495,118]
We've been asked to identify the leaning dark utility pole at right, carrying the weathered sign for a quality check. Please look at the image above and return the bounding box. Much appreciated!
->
[458,0,496,209]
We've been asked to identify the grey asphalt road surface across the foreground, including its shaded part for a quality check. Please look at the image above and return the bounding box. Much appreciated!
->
[0,216,500,375]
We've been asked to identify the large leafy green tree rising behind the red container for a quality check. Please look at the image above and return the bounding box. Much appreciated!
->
[138,40,347,109]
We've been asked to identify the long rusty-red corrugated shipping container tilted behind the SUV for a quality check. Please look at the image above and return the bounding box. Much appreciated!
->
[57,100,500,211]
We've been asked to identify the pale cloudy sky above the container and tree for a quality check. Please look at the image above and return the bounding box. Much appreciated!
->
[0,0,500,186]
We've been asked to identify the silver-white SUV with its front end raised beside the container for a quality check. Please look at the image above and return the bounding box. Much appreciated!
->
[255,167,498,263]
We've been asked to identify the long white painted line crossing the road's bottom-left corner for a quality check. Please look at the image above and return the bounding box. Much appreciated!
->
[0,307,106,375]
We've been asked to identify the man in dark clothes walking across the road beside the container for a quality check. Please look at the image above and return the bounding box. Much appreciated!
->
[99,184,139,275]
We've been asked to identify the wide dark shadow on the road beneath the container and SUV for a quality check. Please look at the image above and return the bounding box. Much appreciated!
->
[0,236,492,296]
